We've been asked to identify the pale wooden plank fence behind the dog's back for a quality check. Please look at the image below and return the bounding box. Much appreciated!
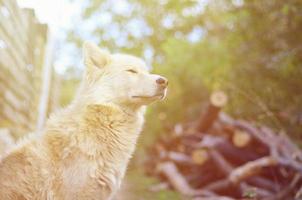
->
[0,0,57,137]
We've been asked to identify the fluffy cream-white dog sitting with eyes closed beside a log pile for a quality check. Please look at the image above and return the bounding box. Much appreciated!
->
[0,42,168,200]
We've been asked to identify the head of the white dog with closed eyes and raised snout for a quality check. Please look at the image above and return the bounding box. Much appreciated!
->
[82,42,168,106]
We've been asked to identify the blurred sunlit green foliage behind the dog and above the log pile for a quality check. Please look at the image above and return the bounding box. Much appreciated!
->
[69,0,302,144]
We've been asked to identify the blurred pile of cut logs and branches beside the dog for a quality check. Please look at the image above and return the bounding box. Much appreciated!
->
[145,92,302,200]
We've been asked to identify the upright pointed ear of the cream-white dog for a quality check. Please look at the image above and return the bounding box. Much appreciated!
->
[83,41,110,68]
